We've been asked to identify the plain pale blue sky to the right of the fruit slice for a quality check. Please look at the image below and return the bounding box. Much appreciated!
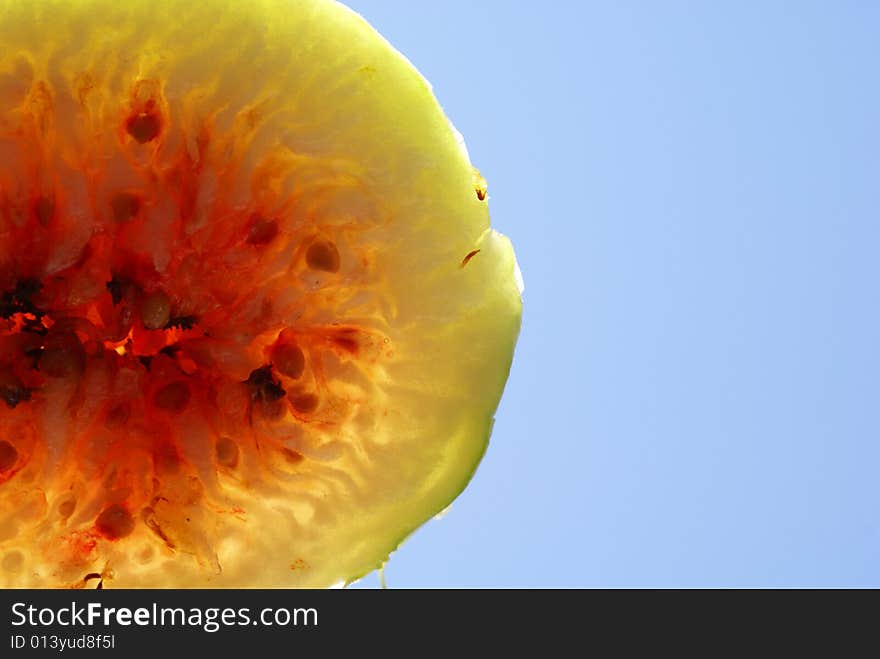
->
[347,0,880,587]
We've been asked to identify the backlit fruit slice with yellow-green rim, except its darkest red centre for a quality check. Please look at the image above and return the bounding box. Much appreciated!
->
[0,0,520,587]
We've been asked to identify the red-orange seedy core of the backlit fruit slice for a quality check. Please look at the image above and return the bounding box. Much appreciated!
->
[0,73,391,574]
